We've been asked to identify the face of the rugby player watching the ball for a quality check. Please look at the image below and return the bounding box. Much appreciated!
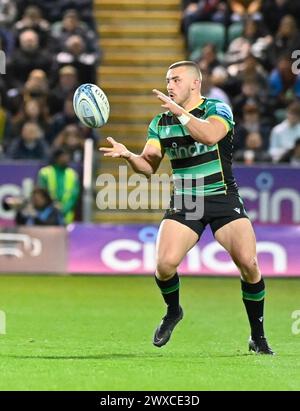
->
[167,66,195,106]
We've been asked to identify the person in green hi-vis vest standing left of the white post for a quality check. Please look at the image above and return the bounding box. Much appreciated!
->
[38,148,80,224]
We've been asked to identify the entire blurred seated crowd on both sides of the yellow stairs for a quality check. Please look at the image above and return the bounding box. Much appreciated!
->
[0,0,300,164]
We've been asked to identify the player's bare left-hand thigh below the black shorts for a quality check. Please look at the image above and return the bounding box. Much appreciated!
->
[156,219,199,266]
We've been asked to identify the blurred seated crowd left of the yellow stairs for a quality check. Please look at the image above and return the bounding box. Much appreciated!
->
[0,0,101,163]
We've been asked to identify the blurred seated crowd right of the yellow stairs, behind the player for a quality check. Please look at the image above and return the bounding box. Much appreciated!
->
[181,0,300,165]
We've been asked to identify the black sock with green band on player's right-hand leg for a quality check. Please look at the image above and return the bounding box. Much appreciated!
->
[241,278,265,339]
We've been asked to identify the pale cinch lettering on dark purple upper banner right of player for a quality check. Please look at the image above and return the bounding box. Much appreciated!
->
[239,172,300,223]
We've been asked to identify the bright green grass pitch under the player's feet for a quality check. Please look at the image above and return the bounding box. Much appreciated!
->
[0,276,300,391]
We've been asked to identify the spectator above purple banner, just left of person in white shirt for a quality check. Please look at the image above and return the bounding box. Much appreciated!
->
[234,131,271,165]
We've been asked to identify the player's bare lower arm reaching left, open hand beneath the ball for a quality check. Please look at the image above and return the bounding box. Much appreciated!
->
[100,137,163,177]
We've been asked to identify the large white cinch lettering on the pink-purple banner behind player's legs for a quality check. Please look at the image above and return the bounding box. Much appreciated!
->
[100,226,288,274]
